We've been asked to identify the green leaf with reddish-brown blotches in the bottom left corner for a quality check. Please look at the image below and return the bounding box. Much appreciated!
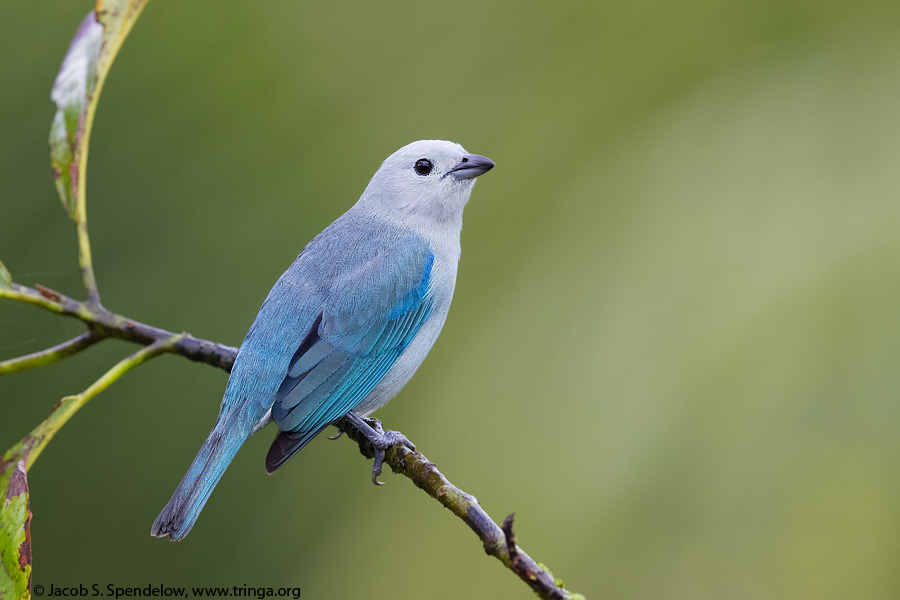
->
[0,454,31,599]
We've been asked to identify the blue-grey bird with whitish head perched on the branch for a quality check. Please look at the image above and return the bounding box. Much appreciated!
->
[151,140,495,541]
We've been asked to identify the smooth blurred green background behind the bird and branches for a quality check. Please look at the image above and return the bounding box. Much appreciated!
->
[0,0,900,600]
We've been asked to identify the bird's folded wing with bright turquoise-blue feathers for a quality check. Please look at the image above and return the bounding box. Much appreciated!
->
[272,239,434,450]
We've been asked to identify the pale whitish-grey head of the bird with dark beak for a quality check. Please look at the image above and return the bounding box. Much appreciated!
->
[360,140,494,226]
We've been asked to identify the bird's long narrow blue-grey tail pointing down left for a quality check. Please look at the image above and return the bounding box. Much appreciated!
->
[150,418,250,542]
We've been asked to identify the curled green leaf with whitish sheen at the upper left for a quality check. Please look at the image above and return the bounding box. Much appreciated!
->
[50,0,147,222]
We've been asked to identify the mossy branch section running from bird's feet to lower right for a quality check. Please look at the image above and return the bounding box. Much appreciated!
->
[336,419,584,600]
